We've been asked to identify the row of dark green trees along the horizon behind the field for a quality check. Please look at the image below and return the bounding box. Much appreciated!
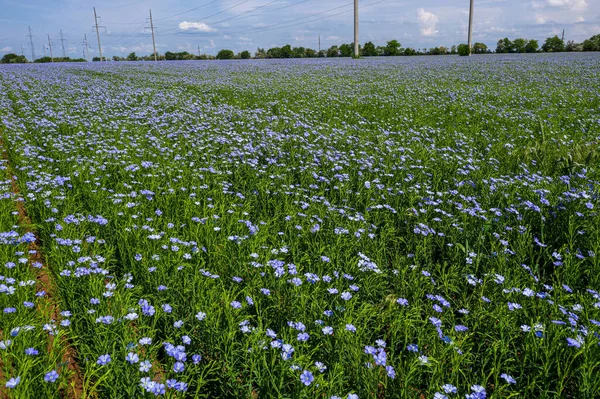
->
[0,35,600,64]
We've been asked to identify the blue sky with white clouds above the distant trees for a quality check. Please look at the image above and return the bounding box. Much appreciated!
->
[0,0,600,57]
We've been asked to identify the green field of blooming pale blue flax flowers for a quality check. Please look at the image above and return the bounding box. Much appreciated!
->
[0,54,600,399]
